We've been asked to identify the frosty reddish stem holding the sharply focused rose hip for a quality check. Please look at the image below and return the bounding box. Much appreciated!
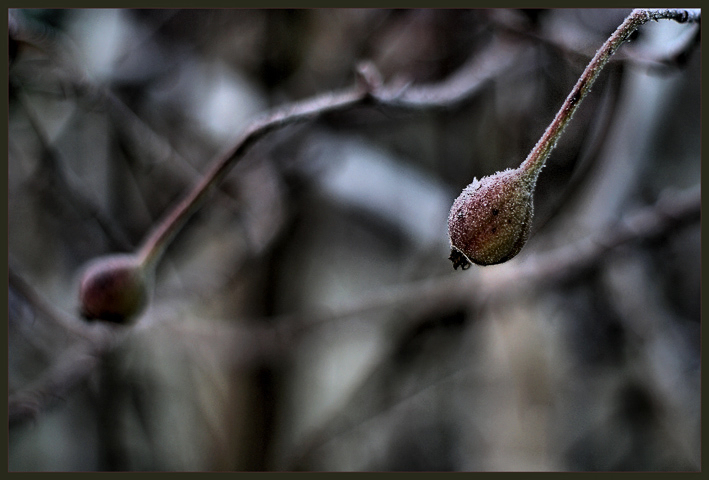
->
[520,8,701,179]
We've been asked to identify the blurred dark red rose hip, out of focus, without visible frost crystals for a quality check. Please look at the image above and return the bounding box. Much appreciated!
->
[79,255,148,323]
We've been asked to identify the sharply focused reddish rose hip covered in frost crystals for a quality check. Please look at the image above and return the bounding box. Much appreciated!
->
[448,168,537,270]
